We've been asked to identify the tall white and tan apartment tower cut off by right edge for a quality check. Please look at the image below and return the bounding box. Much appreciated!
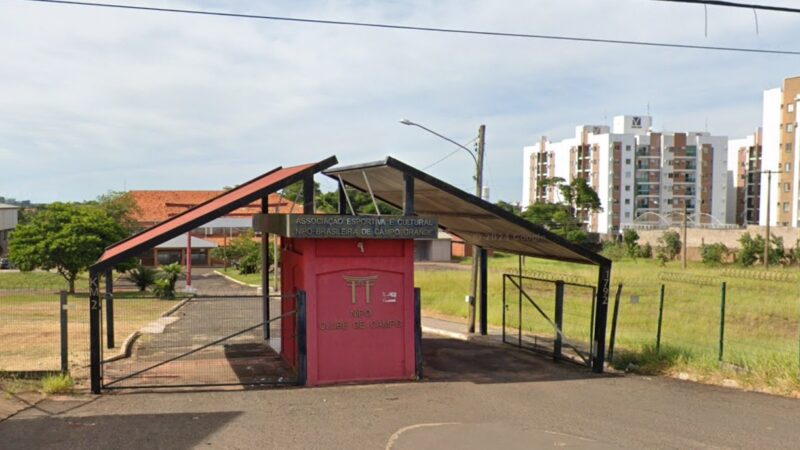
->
[759,76,800,227]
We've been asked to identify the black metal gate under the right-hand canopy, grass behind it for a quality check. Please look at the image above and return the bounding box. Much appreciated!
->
[503,274,597,367]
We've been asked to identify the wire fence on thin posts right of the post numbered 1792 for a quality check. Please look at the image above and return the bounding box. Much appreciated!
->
[609,271,800,379]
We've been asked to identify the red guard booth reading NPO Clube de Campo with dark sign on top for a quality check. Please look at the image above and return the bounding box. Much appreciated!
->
[262,214,437,386]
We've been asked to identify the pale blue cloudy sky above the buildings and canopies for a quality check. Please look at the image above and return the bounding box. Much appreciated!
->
[0,0,800,202]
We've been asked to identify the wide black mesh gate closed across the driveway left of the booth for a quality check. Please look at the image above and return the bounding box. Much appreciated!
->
[97,292,305,389]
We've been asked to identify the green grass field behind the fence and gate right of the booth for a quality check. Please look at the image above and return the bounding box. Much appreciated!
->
[415,255,800,394]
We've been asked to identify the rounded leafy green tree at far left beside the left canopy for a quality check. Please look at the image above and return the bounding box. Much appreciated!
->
[9,203,126,294]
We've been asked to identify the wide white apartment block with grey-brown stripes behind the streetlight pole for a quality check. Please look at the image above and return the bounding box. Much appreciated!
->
[522,116,728,234]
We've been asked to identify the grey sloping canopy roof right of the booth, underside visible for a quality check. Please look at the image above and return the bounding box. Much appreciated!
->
[324,157,611,266]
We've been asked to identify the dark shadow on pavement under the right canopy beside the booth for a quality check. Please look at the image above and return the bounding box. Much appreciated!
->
[422,337,616,383]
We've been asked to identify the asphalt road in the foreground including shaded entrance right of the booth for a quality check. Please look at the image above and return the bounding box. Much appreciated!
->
[0,337,800,450]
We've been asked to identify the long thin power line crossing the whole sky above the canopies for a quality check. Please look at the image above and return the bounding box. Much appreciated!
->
[25,0,800,56]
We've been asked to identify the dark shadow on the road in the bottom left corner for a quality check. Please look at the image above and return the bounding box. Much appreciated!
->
[0,412,241,450]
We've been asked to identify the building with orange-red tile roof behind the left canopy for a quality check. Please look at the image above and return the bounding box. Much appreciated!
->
[128,191,303,267]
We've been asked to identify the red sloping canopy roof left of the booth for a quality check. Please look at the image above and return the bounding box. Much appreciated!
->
[91,156,337,271]
